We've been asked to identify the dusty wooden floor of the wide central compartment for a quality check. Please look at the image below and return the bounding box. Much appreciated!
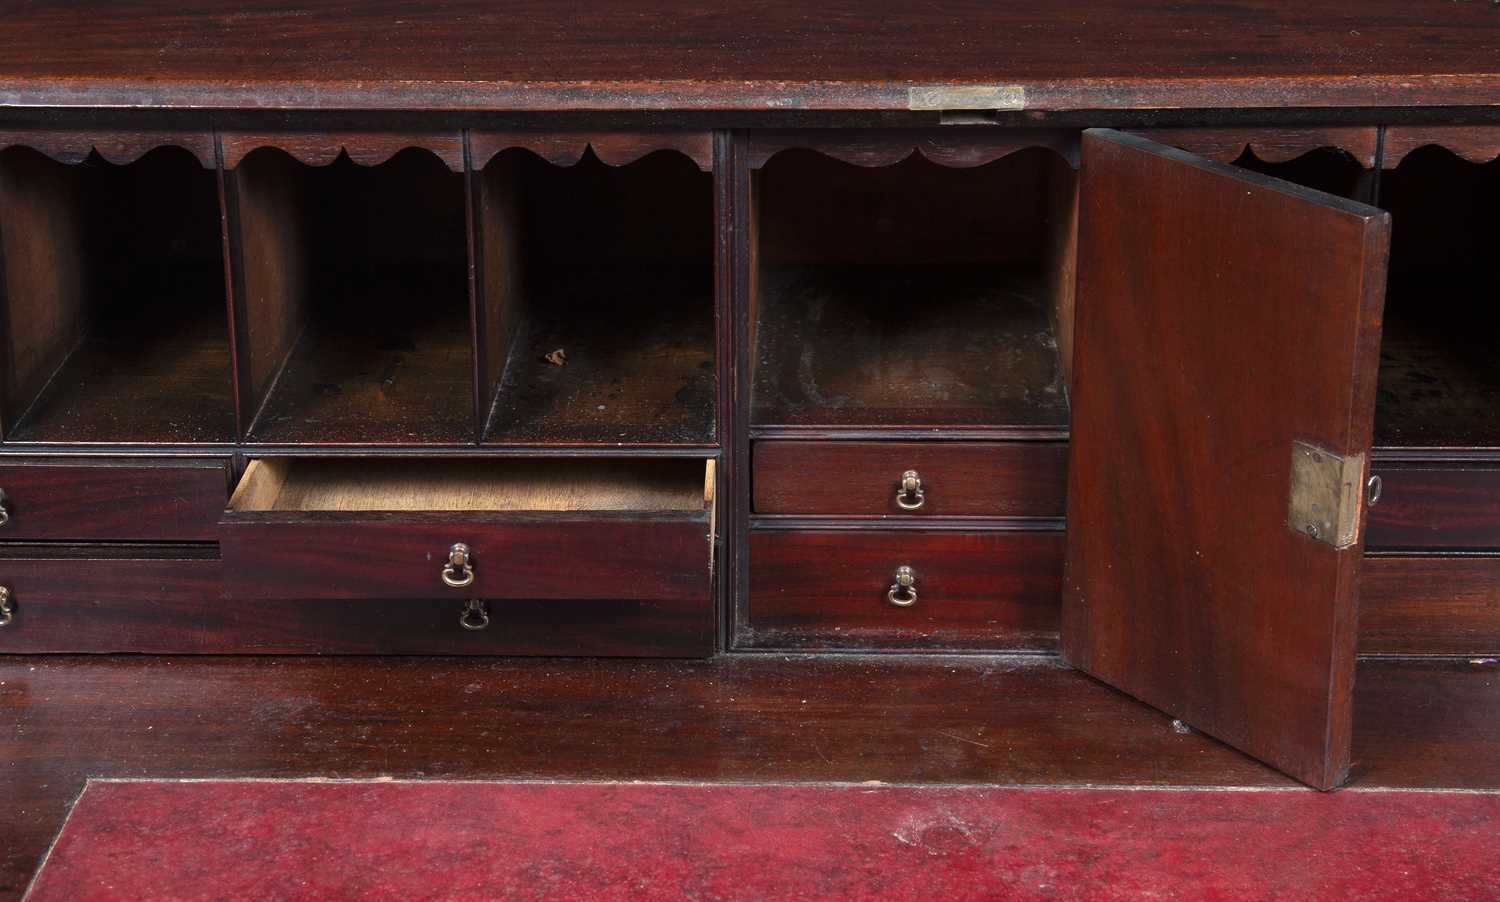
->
[752,266,1068,429]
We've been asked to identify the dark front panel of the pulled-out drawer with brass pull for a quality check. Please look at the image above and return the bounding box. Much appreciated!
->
[219,513,713,606]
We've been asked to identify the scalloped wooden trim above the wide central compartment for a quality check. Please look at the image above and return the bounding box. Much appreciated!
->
[749,128,1079,170]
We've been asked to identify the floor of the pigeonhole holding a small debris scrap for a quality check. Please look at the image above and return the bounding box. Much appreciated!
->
[486,266,714,444]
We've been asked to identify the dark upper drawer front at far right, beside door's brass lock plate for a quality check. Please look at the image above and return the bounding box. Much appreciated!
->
[1365,462,1500,548]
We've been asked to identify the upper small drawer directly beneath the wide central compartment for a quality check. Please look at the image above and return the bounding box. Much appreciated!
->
[753,441,1068,518]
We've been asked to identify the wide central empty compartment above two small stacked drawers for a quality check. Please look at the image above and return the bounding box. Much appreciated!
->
[752,147,1077,432]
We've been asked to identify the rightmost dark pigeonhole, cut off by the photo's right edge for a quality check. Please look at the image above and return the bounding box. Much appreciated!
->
[1376,147,1500,449]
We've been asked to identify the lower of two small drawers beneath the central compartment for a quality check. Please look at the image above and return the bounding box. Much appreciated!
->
[737,528,1064,651]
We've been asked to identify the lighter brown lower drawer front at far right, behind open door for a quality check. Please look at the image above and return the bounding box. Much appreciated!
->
[1359,552,1500,657]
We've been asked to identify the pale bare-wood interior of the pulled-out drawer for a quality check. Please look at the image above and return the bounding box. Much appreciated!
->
[230,458,714,513]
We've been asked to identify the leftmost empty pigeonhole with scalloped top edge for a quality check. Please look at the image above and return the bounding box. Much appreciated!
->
[0,147,234,443]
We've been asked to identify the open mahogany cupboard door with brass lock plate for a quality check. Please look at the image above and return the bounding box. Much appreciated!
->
[1062,131,1391,789]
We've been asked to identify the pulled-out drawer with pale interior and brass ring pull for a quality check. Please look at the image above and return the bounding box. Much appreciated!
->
[219,458,714,603]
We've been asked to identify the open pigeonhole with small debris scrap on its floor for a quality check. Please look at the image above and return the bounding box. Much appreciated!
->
[479,149,714,444]
